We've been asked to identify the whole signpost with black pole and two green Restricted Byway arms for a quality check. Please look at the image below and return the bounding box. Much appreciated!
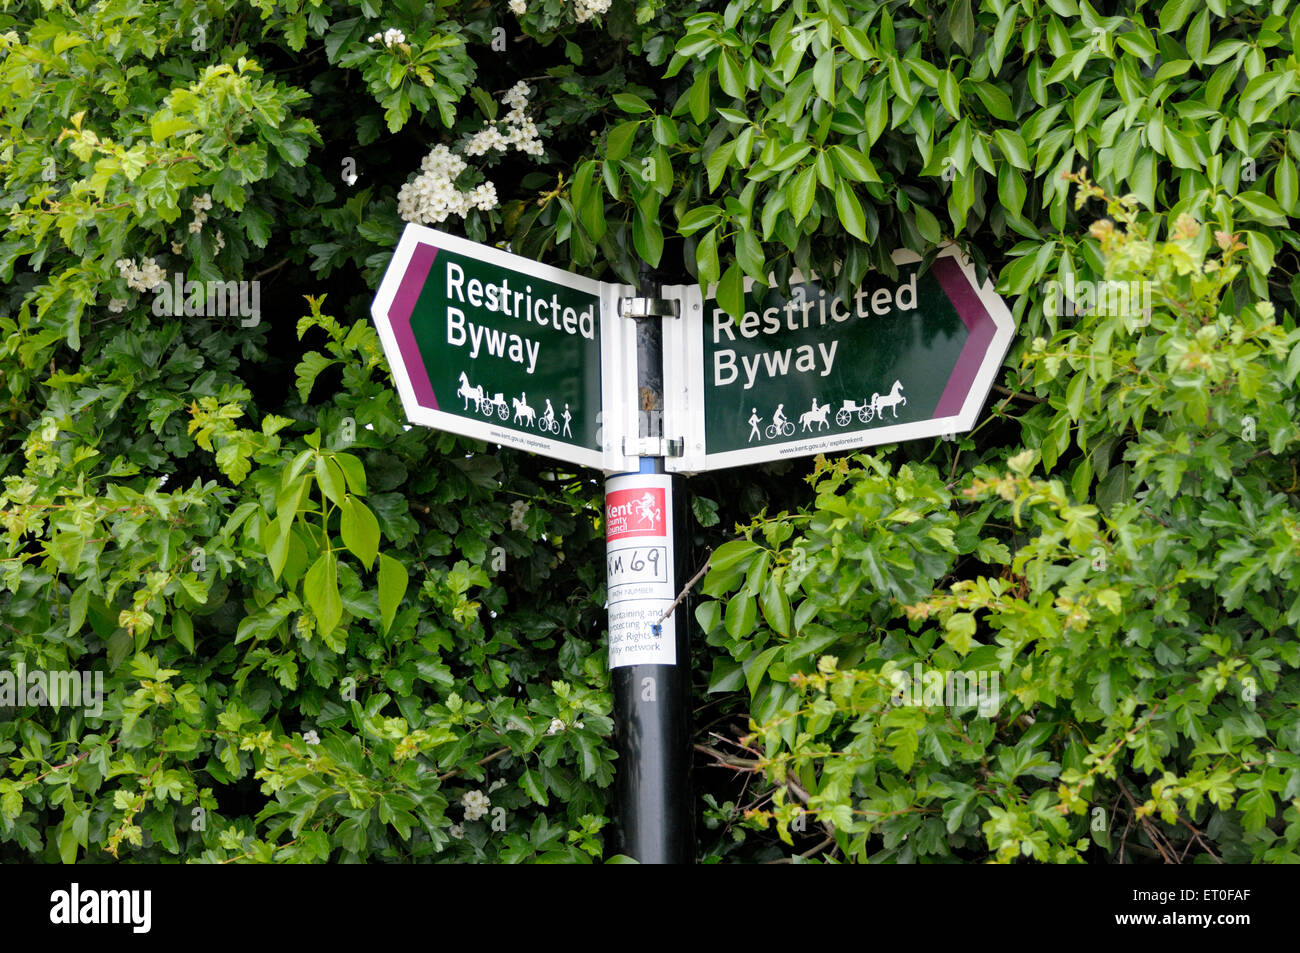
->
[372,225,1013,862]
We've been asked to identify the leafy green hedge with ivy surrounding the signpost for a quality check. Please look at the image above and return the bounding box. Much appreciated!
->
[0,0,1300,862]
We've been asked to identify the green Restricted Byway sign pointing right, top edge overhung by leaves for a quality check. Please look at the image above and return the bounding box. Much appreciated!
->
[666,246,1014,472]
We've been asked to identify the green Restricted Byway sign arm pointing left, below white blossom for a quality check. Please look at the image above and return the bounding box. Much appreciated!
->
[372,225,629,468]
